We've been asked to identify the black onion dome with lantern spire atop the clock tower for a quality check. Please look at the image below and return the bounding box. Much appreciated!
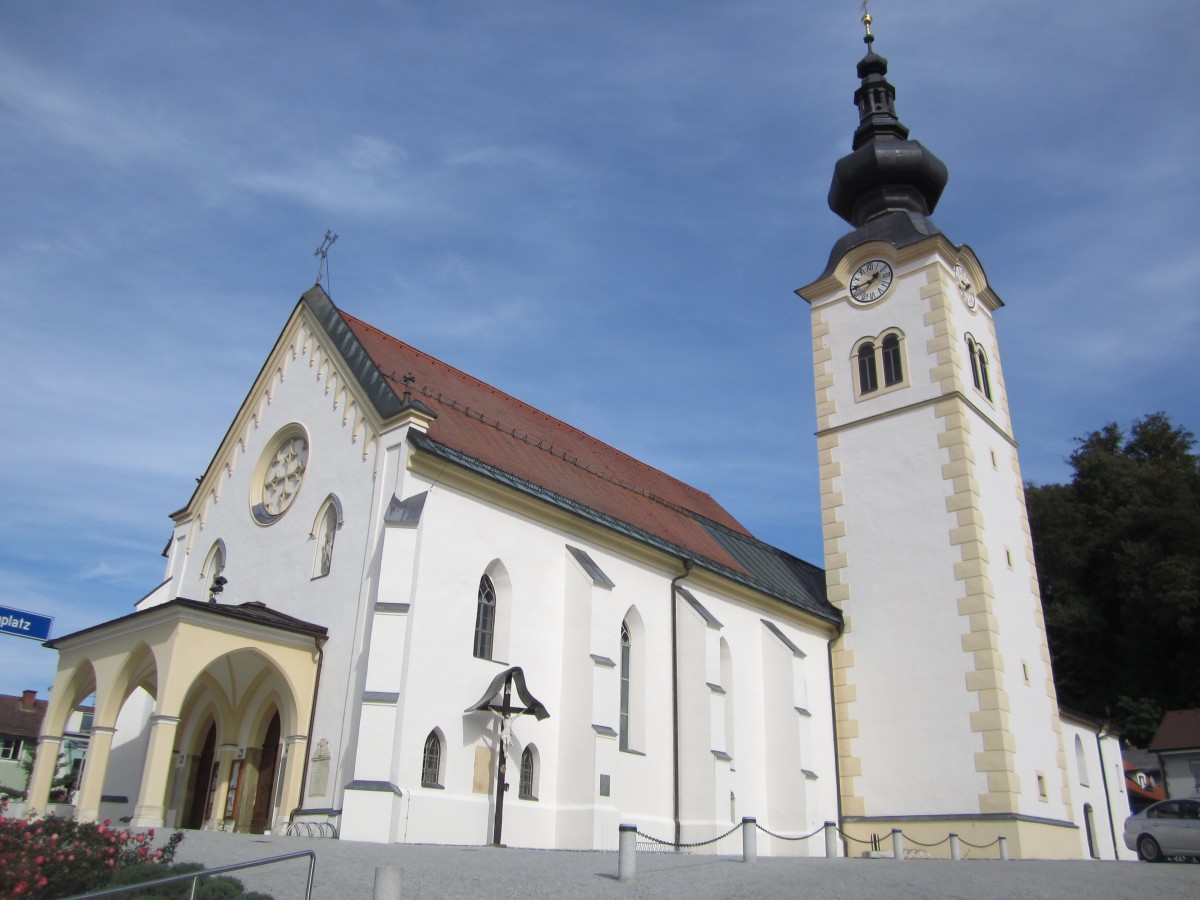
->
[829,34,949,228]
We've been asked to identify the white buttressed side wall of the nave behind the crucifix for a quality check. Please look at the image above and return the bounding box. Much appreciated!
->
[345,472,836,852]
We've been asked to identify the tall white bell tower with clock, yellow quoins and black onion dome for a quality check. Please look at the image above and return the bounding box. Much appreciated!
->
[797,13,1082,858]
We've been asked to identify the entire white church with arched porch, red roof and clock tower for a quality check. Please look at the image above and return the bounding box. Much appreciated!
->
[30,19,1128,859]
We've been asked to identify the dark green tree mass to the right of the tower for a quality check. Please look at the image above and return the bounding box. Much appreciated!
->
[1026,413,1200,739]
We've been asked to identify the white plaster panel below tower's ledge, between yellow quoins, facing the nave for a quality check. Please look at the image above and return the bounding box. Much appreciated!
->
[834,407,986,816]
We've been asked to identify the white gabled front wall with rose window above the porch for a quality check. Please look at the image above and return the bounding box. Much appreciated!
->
[145,321,390,806]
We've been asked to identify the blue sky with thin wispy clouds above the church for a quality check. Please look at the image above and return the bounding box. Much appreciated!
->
[0,0,1200,696]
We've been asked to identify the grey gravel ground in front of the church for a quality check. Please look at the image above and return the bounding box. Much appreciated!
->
[154,832,1200,900]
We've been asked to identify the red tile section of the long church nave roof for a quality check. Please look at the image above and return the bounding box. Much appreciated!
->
[341,312,749,572]
